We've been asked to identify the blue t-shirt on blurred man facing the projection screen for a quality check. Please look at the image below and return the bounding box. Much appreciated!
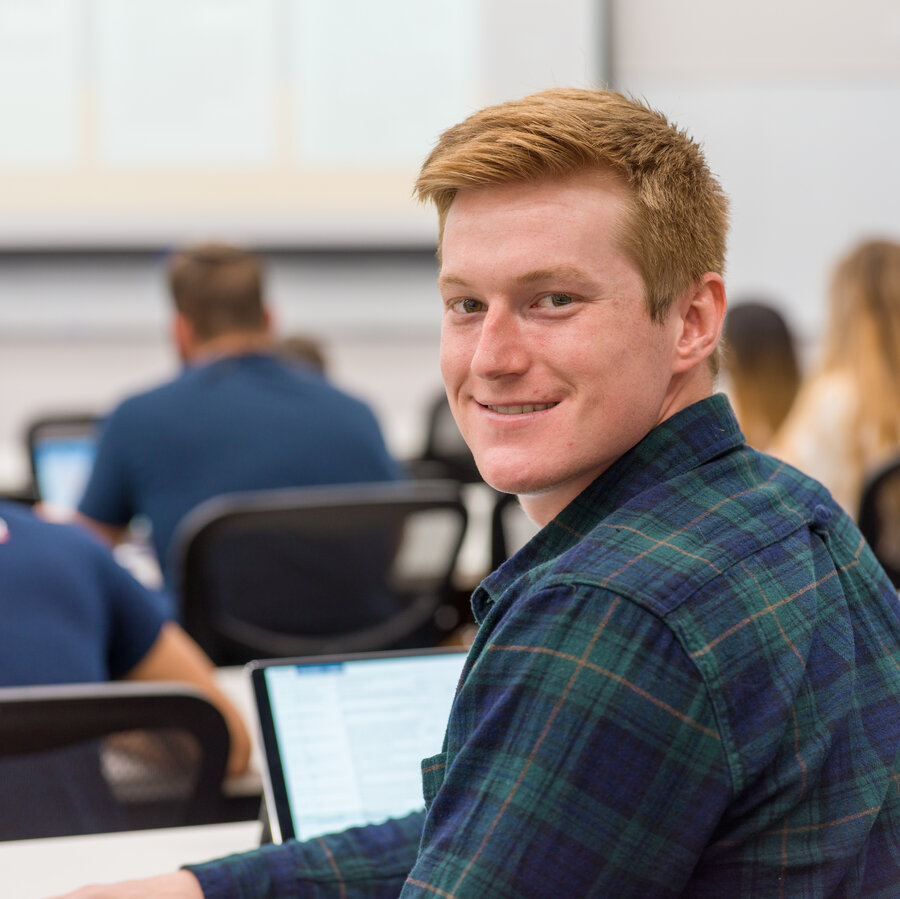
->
[79,354,400,588]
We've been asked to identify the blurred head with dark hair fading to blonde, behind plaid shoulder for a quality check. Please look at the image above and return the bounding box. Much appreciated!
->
[723,300,800,450]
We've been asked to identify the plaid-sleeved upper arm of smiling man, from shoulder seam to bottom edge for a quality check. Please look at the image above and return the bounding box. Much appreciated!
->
[402,586,731,899]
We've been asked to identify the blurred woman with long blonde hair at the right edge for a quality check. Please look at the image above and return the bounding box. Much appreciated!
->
[770,240,900,516]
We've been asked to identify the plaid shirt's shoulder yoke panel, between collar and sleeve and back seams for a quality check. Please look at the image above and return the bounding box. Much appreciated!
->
[544,447,840,614]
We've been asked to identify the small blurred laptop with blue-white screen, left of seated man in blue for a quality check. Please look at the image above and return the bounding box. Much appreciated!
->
[27,416,98,509]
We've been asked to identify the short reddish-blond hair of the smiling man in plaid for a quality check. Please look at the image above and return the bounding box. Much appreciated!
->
[415,88,728,321]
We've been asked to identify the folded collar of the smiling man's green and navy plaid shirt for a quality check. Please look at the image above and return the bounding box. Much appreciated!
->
[472,393,744,622]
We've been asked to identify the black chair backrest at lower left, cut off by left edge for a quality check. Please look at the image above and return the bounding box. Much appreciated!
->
[0,682,230,840]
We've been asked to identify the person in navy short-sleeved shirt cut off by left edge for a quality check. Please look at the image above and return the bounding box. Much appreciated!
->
[0,501,250,839]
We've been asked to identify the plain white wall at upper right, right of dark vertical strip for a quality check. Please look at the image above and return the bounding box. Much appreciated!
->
[613,0,900,343]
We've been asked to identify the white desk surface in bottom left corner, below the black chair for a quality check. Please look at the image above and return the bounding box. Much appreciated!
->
[0,821,262,899]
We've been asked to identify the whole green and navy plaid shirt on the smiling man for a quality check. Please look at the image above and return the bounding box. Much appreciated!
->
[193,396,900,899]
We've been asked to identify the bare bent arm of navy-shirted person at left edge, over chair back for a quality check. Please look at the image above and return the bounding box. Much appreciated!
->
[125,621,250,774]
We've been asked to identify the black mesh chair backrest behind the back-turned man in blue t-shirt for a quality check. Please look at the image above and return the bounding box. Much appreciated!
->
[172,481,467,665]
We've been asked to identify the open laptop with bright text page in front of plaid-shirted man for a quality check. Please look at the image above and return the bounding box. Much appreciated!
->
[247,647,466,843]
